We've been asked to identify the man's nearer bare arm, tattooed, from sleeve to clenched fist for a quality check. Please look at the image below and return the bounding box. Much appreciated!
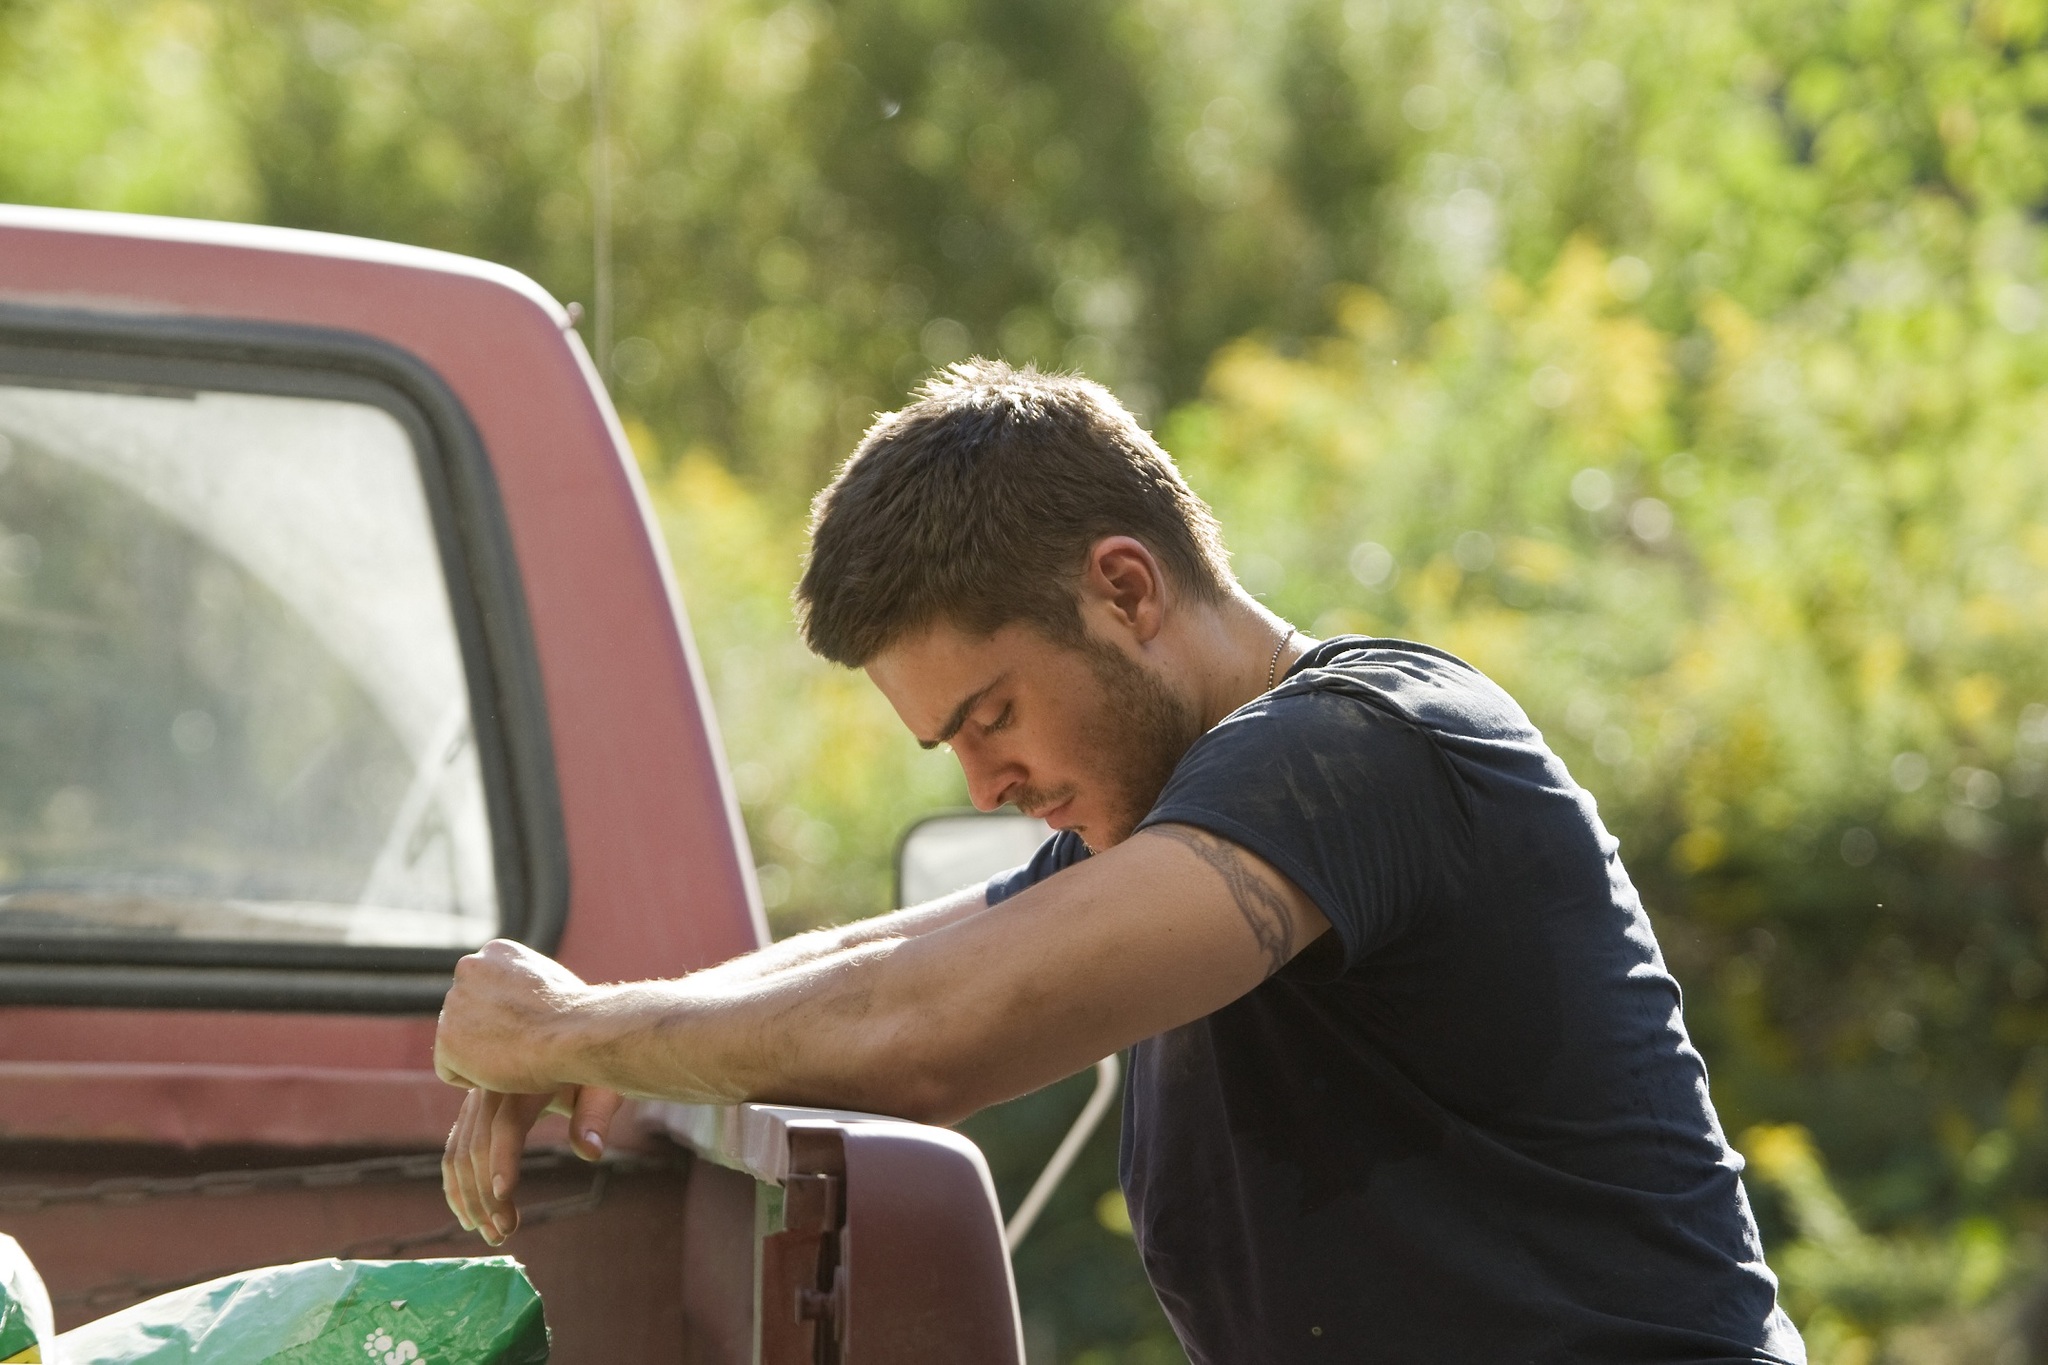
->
[434,831,1327,1121]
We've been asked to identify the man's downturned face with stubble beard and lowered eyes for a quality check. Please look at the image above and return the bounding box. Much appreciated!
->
[866,624,1202,851]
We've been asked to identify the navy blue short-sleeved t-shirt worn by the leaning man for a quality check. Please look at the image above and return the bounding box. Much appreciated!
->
[989,636,1806,1365]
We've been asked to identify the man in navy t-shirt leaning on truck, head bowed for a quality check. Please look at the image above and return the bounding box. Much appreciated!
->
[438,360,1804,1365]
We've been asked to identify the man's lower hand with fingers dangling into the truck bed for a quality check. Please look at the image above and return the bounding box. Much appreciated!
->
[440,1085,621,1246]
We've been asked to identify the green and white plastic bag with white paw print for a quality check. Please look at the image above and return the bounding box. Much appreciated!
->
[55,1257,547,1365]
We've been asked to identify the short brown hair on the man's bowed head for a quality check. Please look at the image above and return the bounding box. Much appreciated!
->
[797,358,1231,667]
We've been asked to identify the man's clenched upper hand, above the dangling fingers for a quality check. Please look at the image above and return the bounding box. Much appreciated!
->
[434,939,592,1095]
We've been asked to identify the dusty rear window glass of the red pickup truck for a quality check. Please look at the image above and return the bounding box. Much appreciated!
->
[0,379,498,950]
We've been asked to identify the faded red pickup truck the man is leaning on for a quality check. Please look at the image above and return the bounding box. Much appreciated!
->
[0,207,1040,1365]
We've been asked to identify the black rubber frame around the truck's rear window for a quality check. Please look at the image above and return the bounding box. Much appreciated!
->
[0,303,569,1013]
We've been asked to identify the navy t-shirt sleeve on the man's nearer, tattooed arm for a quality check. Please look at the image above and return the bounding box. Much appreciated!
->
[1141,688,1470,968]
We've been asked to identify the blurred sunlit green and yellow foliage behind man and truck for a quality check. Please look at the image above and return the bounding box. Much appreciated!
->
[12,0,2048,1365]
